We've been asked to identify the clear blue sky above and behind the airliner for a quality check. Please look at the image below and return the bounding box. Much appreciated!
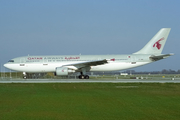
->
[0,0,180,71]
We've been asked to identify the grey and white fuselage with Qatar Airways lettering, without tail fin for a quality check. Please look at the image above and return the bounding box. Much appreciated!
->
[4,54,150,72]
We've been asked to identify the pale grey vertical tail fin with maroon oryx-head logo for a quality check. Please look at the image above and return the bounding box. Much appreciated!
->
[134,28,171,54]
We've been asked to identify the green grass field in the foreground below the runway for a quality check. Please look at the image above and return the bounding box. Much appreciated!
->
[0,83,180,120]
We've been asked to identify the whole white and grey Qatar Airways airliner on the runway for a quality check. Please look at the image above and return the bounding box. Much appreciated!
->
[4,28,173,79]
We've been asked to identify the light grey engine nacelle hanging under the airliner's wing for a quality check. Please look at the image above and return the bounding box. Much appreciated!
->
[55,67,75,76]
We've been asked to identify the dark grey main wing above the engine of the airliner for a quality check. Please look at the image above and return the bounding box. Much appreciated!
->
[64,59,108,69]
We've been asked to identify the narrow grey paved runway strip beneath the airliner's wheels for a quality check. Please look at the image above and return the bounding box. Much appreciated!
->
[0,79,180,83]
